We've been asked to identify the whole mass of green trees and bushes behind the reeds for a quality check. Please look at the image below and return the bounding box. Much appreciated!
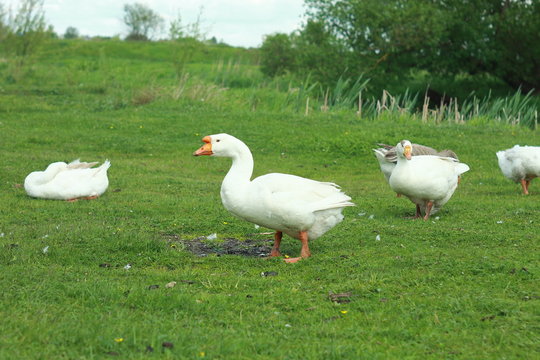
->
[261,0,540,98]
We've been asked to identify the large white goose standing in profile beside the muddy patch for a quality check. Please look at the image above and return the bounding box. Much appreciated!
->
[193,134,354,262]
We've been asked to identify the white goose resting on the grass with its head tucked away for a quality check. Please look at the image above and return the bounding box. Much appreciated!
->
[24,159,111,201]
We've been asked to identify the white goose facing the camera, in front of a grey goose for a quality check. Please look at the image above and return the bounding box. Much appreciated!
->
[389,140,469,220]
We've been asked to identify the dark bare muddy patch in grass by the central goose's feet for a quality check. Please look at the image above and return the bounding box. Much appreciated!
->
[164,234,274,257]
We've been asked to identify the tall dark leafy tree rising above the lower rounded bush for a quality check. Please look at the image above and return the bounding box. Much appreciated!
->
[305,0,540,90]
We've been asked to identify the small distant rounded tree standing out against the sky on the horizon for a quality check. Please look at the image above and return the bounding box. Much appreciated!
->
[124,3,163,40]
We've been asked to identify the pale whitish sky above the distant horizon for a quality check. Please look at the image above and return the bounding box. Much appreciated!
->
[0,0,304,47]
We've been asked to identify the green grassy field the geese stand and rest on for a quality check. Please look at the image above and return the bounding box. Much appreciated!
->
[0,42,540,359]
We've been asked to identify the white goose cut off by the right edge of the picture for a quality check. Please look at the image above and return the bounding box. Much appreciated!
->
[497,145,540,195]
